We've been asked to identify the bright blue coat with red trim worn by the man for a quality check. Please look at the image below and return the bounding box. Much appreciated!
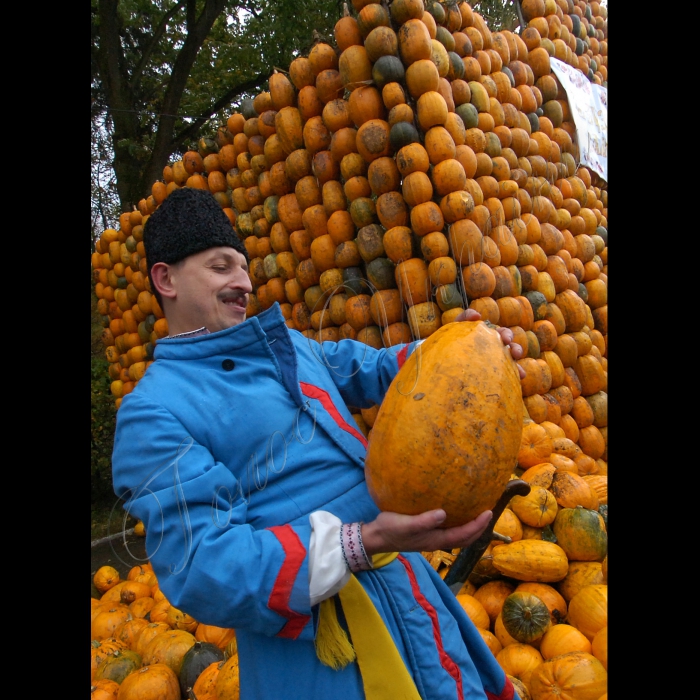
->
[112,305,517,700]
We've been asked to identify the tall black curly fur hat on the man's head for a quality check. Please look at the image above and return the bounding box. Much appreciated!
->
[143,187,250,284]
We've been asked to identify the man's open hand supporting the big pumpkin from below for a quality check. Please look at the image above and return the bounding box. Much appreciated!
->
[362,508,491,556]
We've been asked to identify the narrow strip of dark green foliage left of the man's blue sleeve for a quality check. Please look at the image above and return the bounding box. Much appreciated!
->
[90,284,116,507]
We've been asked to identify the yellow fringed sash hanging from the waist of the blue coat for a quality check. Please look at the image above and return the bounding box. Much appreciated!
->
[315,552,420,700]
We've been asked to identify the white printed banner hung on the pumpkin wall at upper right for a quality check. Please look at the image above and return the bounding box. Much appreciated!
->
[549,58,608,182]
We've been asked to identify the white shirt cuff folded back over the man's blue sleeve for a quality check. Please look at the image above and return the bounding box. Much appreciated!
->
[309,510,351,605]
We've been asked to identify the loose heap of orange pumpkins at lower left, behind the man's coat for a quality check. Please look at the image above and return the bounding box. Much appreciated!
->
[90,563,239,700]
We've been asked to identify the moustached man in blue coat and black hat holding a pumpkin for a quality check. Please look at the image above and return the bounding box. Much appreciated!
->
[113,188,521,700]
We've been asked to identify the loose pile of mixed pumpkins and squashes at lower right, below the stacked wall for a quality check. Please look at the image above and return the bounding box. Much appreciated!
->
[424,422,608,700]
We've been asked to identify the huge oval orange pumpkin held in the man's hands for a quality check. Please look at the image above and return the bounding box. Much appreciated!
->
[365,321,523,527]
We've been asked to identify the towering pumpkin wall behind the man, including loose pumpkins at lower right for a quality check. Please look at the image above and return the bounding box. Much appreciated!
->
[92,0,608,699]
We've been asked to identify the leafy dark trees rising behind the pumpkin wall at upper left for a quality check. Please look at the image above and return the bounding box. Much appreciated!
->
[91,0,342,239]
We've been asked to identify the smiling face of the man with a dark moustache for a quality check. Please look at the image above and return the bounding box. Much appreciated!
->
[168,246,253,334]
